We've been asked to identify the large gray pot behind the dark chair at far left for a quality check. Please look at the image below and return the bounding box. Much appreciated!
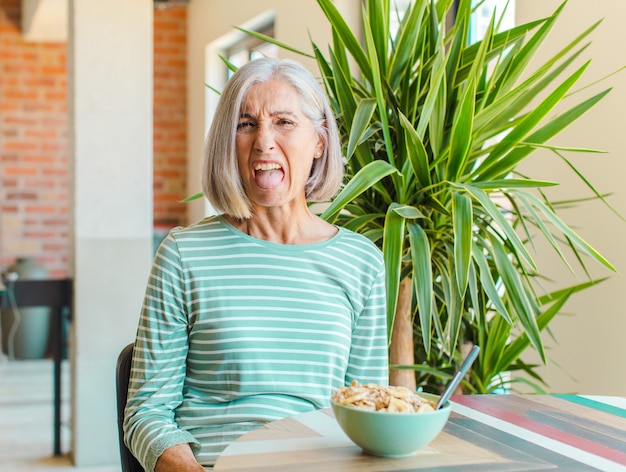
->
[0,258,51,359]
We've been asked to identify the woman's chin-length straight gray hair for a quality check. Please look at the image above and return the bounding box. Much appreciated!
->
[202,58,344,219]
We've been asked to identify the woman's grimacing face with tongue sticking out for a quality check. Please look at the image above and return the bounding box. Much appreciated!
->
[236,79,323,214]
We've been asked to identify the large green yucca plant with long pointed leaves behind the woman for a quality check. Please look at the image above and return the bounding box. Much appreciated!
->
[236,0,614,393]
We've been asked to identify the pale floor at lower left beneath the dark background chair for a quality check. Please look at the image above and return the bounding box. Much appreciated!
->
[0,354,120,472]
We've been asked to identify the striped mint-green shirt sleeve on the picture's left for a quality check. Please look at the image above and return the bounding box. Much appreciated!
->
[124,234,199,471]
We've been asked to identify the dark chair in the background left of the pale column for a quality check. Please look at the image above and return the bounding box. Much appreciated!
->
[0,278,74,456]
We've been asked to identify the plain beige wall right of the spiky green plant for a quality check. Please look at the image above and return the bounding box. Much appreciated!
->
[516,0,626,395]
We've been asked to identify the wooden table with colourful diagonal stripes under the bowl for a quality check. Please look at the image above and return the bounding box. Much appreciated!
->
[214,395,626,472]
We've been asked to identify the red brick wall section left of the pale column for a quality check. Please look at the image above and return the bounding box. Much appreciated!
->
[0,0,69,276]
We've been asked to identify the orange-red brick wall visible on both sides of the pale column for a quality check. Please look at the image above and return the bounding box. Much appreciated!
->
[0,0,187,277]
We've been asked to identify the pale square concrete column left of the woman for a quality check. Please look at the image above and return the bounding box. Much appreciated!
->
[68,0,153,466]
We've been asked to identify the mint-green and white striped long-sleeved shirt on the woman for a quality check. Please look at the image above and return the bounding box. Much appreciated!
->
[125,216,388,471]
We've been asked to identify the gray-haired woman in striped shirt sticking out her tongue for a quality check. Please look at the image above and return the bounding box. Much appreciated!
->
[125,59,388,472]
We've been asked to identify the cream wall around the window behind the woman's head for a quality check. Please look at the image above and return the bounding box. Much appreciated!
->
[187,0,361,222]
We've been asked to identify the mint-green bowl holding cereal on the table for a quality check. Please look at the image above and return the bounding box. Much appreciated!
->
[331,392,451,457]
